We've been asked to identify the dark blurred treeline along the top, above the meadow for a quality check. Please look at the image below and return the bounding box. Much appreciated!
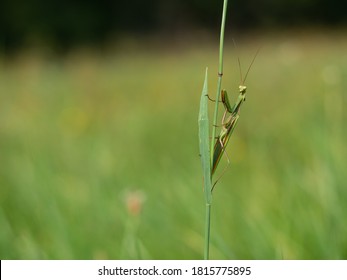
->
[0,0,347,49]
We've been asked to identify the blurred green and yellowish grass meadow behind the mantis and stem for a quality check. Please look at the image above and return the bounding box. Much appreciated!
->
[0,31,347,259]
